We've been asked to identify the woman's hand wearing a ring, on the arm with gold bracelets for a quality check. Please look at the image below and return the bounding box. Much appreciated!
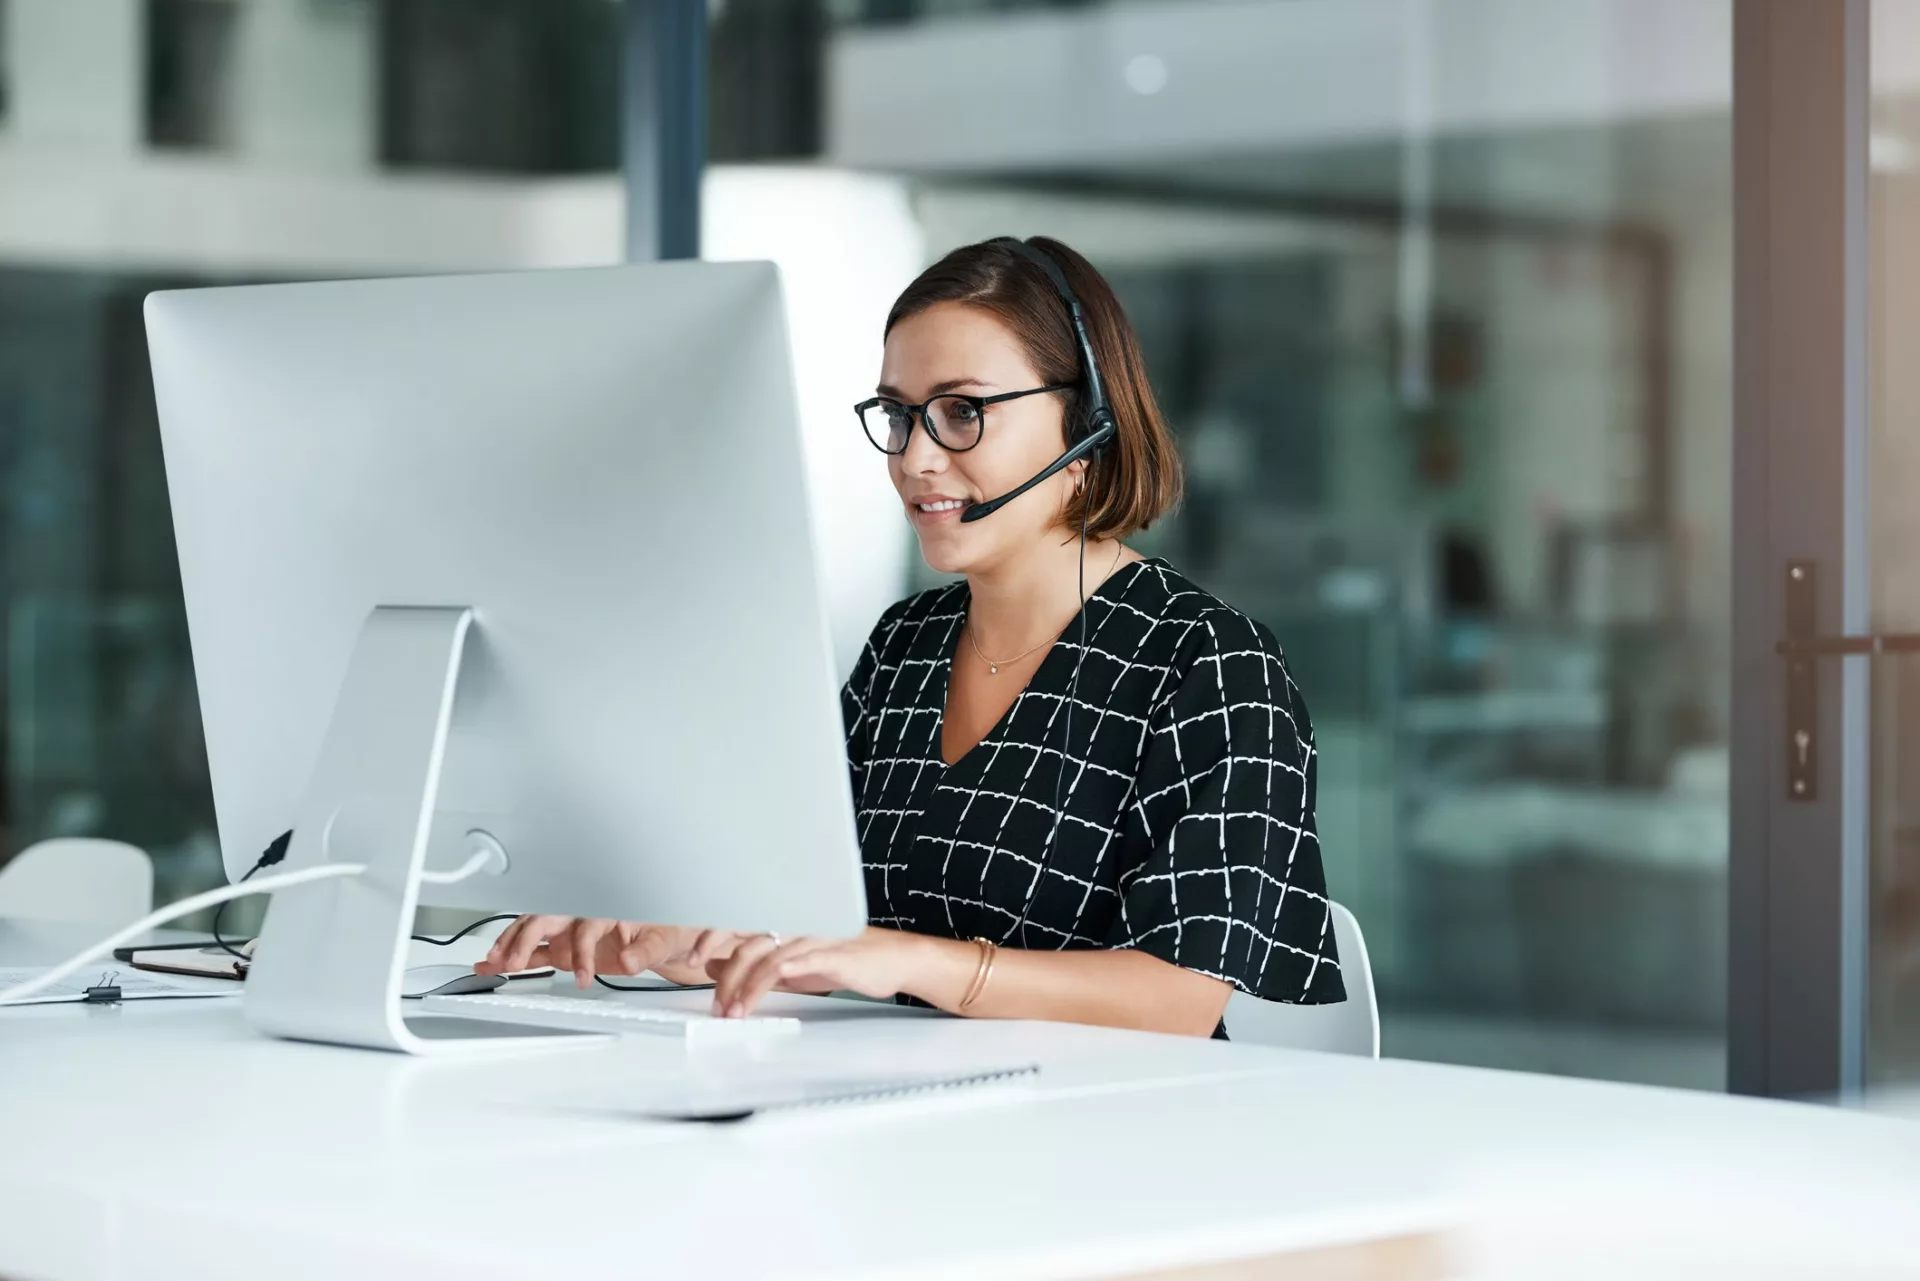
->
[707,926,927,1018]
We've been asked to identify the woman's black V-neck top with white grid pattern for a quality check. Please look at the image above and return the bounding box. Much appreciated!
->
[841,559,1346,1004]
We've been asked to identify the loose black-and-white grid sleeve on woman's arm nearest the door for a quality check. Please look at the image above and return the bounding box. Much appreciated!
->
[1110,611,1346,1004]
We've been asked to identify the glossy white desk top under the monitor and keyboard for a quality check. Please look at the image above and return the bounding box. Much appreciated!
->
[0,922,1920,1281]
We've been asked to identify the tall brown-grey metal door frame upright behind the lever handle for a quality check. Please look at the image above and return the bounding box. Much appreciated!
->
[1728,0,1870,1099]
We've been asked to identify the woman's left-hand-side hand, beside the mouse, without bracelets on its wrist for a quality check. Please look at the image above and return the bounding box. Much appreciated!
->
[474,916,741,987]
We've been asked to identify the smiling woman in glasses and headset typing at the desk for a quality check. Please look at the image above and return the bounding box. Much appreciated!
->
[480,238,1344,1035]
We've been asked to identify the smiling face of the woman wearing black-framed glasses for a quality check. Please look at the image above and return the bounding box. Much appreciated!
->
[877,302,1083,574]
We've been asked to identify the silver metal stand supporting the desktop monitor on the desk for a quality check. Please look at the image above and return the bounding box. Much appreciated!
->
[244,605,605,1054]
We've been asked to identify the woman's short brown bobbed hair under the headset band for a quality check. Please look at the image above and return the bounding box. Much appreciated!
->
[887,236,1183,538]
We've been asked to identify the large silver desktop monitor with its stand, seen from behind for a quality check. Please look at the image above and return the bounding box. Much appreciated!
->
[146,263,866,1051]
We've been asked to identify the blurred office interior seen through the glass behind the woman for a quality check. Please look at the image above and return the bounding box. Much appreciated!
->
[0,0,1766,1089]
